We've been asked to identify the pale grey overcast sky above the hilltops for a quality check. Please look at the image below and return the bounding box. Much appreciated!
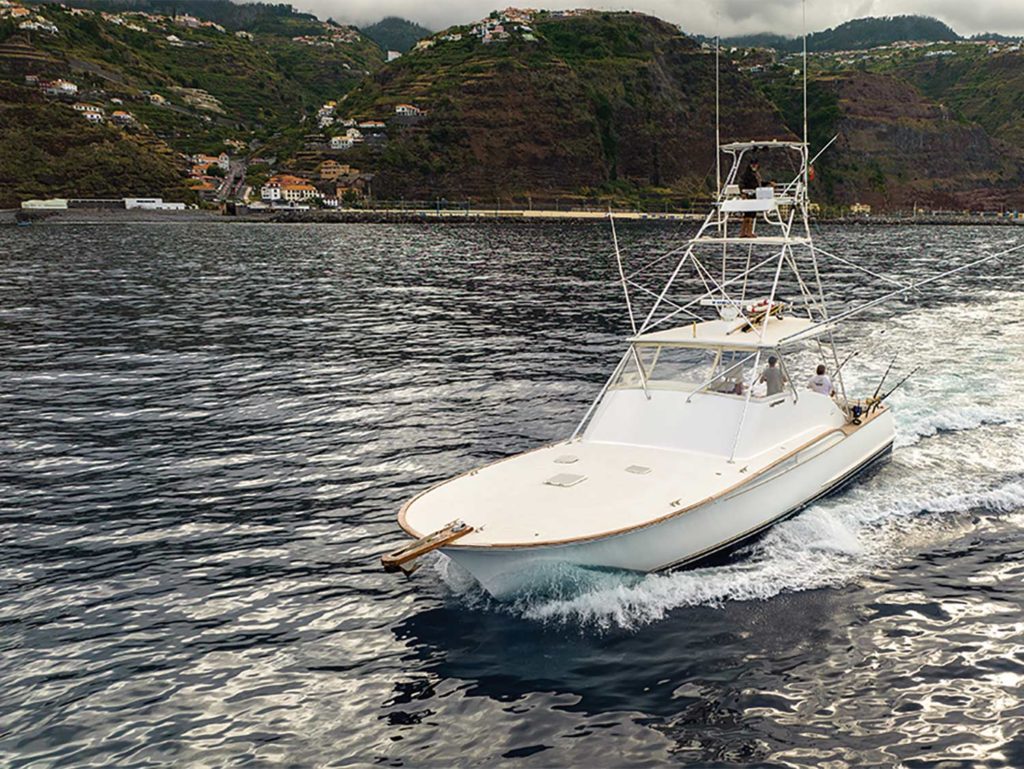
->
[303,0,1024,36]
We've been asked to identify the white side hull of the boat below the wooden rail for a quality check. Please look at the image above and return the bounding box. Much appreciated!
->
[441,411,894,598]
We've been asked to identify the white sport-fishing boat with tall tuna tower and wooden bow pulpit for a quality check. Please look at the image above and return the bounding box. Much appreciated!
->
[384,135,894,597]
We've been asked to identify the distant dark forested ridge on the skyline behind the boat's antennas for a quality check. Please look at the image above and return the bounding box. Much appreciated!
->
[722,15,959,52]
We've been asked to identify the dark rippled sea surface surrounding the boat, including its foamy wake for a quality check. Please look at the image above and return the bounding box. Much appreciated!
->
[0,223,1024,767]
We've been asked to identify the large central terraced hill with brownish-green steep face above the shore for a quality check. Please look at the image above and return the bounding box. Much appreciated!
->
[323,12,787,201]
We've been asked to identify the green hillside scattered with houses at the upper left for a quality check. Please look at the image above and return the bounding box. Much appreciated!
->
[0,0,383,153]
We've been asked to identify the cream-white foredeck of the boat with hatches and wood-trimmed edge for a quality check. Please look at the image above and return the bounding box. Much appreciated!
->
[399,433,821,547]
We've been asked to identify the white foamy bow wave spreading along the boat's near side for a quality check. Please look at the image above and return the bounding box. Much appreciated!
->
[438,478,1024,630]
